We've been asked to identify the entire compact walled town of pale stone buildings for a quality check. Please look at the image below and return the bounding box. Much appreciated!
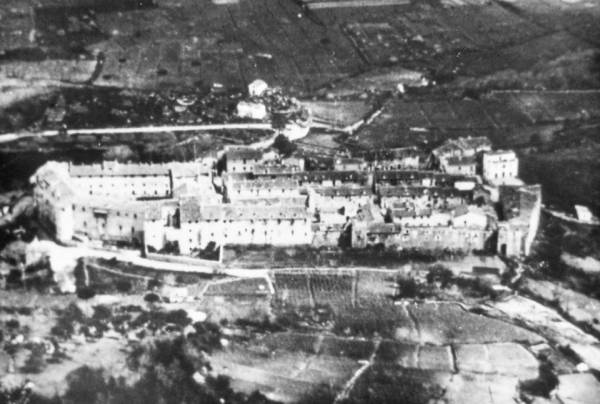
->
[32,137,541,256]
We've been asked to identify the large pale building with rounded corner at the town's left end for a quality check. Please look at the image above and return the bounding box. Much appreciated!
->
[31,162,218,245]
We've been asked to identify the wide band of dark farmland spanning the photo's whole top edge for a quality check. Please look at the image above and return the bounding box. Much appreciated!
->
[0,0,598,93]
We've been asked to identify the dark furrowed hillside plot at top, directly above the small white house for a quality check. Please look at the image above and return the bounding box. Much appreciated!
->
[88,0,364,92]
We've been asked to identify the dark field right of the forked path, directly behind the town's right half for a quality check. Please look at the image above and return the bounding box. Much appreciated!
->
[354,91,600,148]
